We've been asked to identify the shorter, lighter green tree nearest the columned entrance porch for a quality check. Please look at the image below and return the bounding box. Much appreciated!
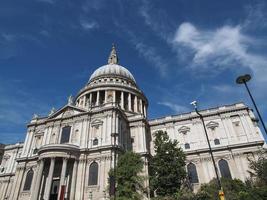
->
[109,151,144,200]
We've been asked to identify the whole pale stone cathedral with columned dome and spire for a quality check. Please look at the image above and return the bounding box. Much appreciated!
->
[0,47,264,200]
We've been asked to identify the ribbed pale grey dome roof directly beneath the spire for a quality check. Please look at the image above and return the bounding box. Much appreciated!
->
[89,63,135,83]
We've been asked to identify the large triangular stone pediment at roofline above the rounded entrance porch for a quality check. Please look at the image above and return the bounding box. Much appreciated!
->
[48,105,86,119]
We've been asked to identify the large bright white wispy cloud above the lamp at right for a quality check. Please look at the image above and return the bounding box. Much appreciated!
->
[173,22,267,82]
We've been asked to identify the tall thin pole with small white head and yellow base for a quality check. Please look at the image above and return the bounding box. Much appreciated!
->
[191,101,224,200]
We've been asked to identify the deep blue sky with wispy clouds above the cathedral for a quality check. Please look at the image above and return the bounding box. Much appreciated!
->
[0,0,267,143]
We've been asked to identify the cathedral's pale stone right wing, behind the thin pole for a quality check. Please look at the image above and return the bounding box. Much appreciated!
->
[149,103,264,190]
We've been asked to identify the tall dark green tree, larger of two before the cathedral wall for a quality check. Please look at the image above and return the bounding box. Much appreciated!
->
[149,131,186,197]
